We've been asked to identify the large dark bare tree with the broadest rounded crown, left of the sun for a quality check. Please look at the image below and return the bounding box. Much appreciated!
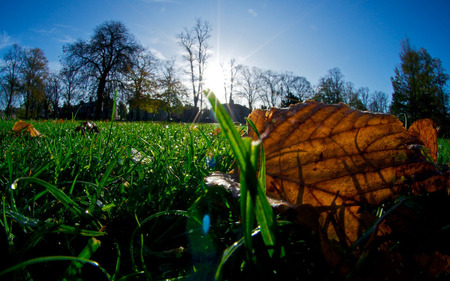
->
[63,21,142,118]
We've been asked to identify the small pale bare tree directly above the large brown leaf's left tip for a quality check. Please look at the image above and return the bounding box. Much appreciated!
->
[236,66,262,111]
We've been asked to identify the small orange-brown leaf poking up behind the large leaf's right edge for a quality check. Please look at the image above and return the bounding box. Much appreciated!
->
[408,118,437,162]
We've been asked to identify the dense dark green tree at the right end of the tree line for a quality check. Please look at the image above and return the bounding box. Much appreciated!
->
[390,39,450,134]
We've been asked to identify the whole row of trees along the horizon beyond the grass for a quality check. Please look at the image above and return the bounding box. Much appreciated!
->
[0,18,449,135]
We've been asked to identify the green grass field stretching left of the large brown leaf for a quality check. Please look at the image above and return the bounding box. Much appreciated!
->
[0,110,449,280]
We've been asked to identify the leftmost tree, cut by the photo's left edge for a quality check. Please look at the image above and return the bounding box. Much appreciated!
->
[0,44,25,117]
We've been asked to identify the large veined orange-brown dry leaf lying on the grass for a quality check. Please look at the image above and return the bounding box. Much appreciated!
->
[249,101,448,246]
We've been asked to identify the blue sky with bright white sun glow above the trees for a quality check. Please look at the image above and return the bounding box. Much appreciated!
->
[0,0,450,103]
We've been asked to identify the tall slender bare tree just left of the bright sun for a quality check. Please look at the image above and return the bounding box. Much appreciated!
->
[177,18,212,108]
